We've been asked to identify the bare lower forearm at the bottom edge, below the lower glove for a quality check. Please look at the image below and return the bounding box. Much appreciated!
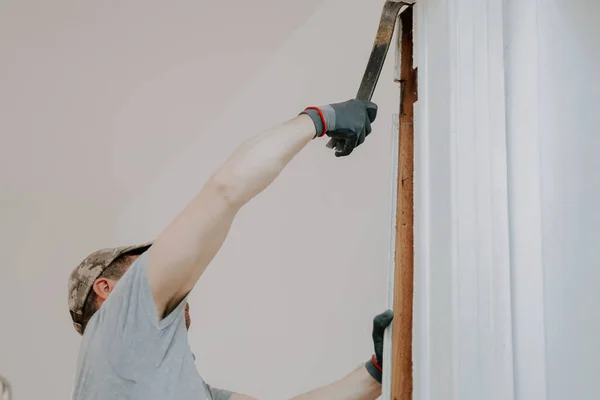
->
[291,366,381,400]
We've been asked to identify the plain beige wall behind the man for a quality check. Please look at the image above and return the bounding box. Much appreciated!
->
[0,0,398,399]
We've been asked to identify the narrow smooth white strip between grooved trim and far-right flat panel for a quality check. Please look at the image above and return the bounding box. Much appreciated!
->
[505,0,547,400]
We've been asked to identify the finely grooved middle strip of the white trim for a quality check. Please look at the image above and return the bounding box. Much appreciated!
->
[450,0,513,400]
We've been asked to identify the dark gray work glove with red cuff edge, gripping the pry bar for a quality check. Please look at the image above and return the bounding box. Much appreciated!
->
[301,100,377,157]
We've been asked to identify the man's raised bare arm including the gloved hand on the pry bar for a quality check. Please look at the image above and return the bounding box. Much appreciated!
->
[147,100,377,318]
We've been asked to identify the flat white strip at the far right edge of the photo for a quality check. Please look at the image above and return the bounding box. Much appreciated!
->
[539,0,600,400]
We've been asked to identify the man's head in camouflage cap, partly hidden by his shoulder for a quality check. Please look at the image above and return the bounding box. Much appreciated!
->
[69,243,190,335]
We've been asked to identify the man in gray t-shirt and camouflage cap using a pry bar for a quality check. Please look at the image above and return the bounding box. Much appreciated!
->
[69,100,392,400]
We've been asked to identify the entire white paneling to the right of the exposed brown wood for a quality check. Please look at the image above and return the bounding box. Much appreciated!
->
[415,0,600,400]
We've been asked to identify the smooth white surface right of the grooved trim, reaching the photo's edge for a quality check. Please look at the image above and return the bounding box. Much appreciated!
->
[507,0,600,400]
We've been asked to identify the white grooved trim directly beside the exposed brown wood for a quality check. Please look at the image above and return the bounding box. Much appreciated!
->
[415,0,514,400]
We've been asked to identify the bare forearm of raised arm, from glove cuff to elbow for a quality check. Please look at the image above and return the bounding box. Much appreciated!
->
[211,115,316,206]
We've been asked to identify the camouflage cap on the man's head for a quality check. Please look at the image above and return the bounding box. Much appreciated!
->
[69,242,152,335]
